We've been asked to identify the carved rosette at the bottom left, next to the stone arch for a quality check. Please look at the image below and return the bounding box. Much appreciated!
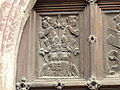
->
[16,78,31,90]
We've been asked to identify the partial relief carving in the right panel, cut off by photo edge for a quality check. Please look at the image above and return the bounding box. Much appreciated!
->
[107,15,120,77]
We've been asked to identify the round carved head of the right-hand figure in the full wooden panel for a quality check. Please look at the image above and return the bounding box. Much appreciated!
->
[66,16,78,27]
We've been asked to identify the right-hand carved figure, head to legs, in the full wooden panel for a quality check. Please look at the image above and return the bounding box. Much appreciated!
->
[61,16,79,46]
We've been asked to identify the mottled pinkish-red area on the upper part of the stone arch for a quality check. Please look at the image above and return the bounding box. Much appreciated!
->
[0,0,36,53]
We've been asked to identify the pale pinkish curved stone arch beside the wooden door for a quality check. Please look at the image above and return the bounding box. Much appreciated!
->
[0,0,36,90]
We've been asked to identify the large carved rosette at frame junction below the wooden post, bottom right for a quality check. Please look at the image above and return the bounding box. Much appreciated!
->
[86,77,101,90]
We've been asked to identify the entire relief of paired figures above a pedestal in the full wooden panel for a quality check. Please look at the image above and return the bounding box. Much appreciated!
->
[39,15,79,77]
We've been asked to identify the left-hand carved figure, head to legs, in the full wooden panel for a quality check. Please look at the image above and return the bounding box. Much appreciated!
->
[39,16,59,47]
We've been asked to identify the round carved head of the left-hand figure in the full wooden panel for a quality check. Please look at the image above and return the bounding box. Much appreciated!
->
[42,16,54,29]
